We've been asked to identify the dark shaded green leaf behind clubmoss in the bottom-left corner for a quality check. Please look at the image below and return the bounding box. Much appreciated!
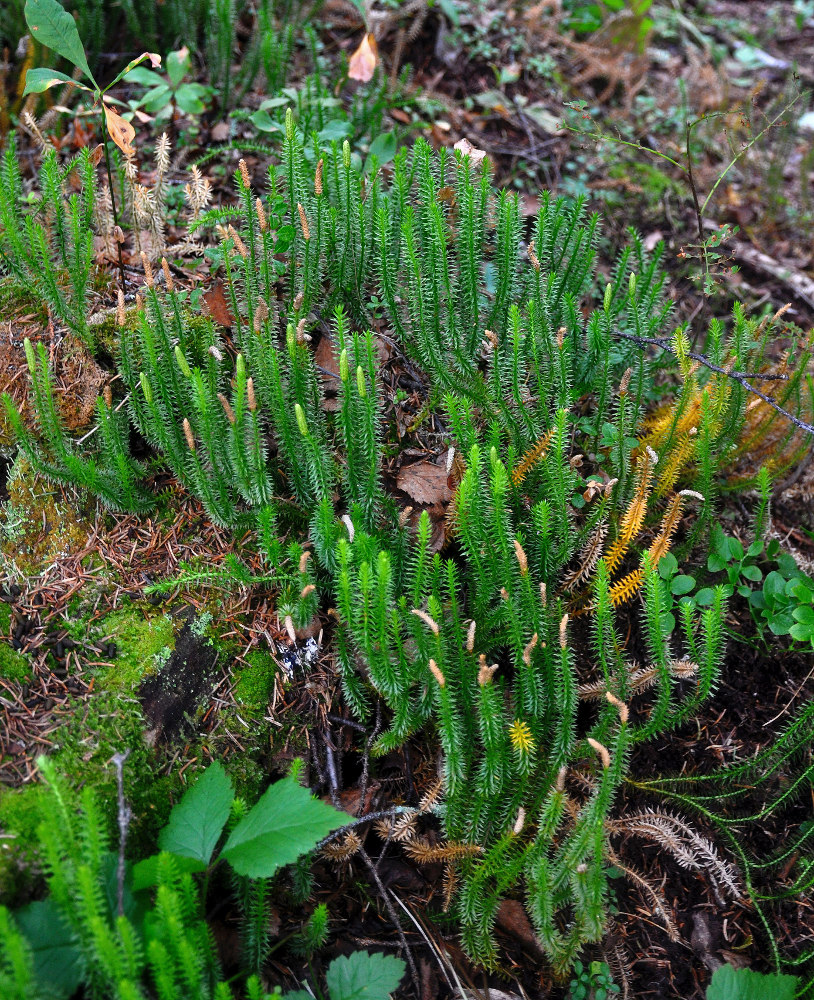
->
[14,899,85,1000]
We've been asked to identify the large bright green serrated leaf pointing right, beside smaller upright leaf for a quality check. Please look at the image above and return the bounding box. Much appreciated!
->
[221,778,350,878]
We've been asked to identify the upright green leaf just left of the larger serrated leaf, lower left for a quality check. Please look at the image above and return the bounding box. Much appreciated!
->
[158,763,235,865]
